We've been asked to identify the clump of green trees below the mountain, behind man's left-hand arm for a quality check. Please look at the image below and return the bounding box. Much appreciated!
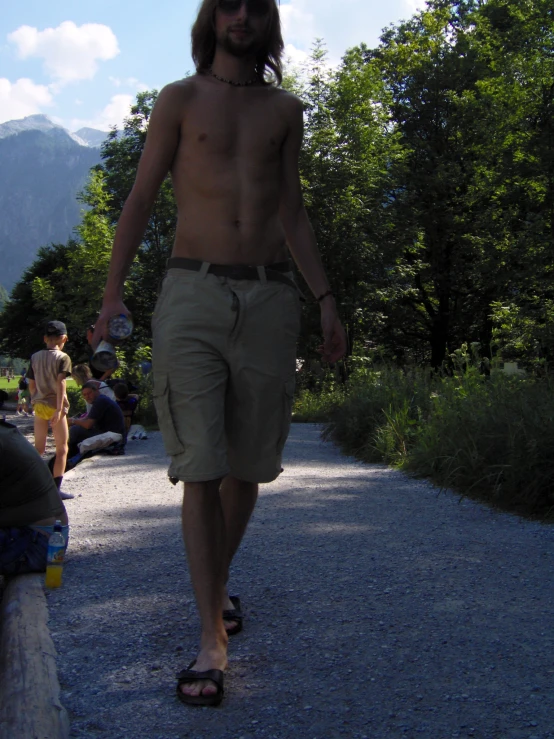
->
[0,91,176,362]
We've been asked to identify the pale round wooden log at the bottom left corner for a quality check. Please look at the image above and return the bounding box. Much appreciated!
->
[0,574,69,739]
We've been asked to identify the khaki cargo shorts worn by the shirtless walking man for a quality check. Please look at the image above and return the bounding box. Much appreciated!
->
[152,263,301,483]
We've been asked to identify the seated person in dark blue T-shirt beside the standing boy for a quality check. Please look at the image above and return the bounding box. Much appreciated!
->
[68,380,126,458]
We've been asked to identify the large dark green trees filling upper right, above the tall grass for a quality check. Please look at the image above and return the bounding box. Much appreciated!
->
[367,0,554,366]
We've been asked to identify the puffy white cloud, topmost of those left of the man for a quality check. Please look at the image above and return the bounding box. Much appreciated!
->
[8,21,119,84]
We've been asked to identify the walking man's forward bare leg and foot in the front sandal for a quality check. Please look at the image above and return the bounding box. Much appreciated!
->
[181,480,228,696]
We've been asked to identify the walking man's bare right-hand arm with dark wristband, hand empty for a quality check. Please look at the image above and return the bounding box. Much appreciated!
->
[279,96,346,362]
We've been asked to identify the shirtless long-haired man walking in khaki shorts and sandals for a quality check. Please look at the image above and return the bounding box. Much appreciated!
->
[93,0,346,705]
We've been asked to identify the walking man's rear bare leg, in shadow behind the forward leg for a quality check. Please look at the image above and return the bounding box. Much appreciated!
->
[219,475,258,629]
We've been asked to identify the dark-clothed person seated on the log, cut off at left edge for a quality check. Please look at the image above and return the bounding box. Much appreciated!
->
[0,421,69,575]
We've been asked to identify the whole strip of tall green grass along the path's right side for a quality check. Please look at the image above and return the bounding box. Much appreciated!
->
[297,366,554,516]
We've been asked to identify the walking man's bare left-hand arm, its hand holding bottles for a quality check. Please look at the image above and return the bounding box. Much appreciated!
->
[92,82,186,347]
